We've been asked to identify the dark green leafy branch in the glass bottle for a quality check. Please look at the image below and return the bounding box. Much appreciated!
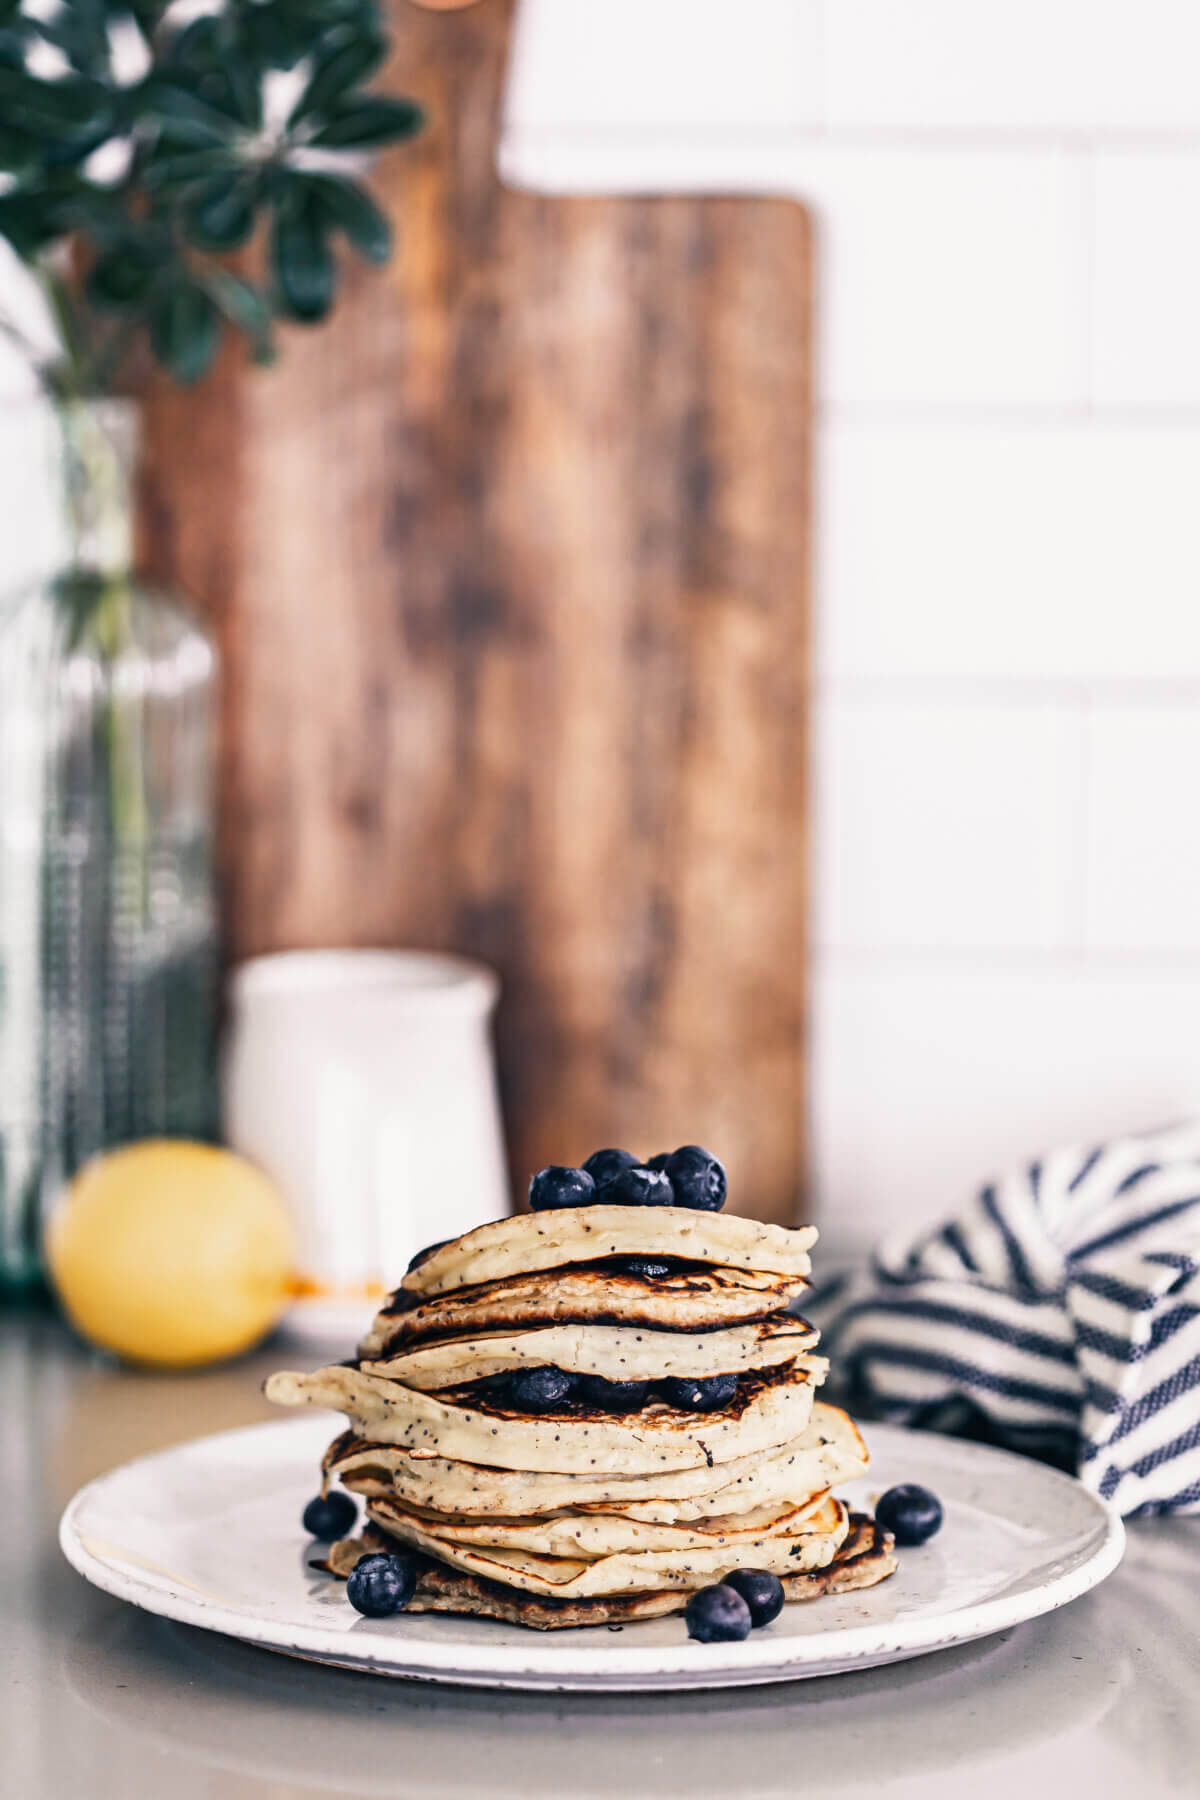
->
[0,0,423,394]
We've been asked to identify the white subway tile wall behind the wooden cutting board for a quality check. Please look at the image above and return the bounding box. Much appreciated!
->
[9,0,1200,1244]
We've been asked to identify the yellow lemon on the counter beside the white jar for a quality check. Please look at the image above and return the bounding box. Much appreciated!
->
[47,1139,295,1368]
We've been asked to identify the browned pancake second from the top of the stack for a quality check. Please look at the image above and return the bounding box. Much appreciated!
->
[360,1264,808,1359]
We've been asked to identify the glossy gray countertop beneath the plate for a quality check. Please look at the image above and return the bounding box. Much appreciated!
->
[0,1312,1200,1800]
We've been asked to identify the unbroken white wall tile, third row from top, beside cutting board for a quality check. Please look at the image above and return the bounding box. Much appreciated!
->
[817,412,1200,682]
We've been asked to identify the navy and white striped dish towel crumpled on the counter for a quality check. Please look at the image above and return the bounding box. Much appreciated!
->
[801,1123,1200,1516]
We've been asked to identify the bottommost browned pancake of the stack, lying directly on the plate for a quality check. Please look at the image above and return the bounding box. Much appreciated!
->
[326,1512,896,1631]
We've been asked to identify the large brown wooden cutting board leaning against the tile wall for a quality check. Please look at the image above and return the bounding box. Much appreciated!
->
[144,0,811,1220]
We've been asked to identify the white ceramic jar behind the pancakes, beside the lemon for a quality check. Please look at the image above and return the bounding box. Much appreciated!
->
[223,950,511,1348]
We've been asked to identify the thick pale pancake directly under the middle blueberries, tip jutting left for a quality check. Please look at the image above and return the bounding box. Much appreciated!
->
[264,1357,824,1476]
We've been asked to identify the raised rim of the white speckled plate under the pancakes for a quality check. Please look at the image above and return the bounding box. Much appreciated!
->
[59,1420,1124,1692]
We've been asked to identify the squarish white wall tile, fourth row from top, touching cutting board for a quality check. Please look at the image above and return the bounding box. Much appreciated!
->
[815,682,1087,952]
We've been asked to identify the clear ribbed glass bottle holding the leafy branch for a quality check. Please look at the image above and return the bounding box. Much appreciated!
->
[0,401,216,1289]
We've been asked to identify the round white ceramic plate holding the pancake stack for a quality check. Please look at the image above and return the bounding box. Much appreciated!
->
[59,1417,1124,1690]
